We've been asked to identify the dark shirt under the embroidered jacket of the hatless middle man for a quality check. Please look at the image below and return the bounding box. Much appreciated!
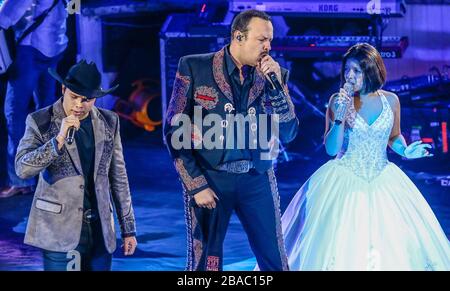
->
[222,46,255,163]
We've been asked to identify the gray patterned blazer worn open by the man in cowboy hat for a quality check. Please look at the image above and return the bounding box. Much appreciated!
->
[15,98,136,253]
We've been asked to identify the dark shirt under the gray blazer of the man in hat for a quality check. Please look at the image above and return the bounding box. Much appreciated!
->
[75,114,97,210]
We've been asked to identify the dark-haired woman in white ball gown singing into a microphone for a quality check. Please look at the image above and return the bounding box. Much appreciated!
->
[282,44,450,270]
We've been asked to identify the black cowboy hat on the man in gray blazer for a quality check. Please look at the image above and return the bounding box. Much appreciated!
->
[48,60,119,99]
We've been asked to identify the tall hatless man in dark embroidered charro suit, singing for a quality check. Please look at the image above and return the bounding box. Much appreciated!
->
[165,10,298,271]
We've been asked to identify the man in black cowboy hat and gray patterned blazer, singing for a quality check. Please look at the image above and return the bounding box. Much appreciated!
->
[15,60,137,270]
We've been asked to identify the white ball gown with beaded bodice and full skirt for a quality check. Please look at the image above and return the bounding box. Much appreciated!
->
[282,95,450,270]
